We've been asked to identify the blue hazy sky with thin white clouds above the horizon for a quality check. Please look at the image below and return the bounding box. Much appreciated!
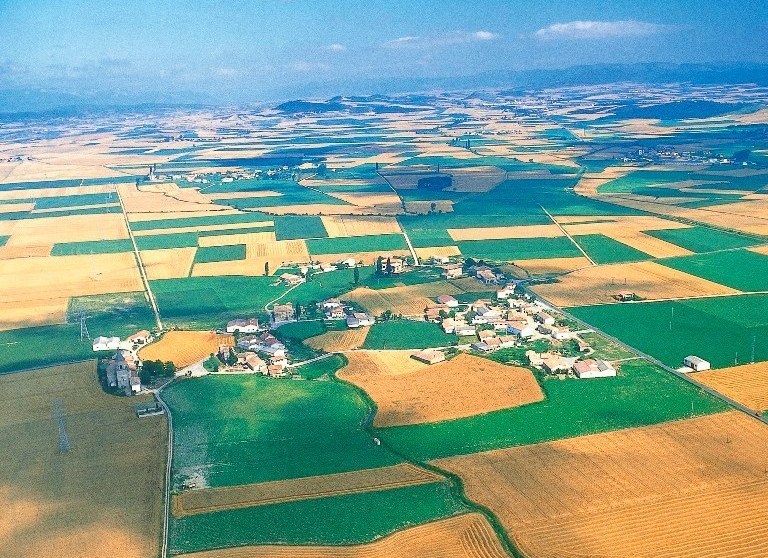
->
[0,0,768,102]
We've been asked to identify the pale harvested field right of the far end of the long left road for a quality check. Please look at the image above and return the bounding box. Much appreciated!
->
[117,183,226,213]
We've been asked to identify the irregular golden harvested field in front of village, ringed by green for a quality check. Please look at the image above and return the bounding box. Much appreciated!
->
[337,351,544,427]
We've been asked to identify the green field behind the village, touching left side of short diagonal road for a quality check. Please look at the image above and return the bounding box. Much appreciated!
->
[455,236,582,261]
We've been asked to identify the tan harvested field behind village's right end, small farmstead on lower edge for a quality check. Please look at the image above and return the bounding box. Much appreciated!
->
[532,262,739,306]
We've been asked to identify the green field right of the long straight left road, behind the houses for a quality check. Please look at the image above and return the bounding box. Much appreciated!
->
[150,276,287,329]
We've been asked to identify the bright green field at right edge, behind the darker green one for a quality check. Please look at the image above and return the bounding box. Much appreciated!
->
[659,250,768,292]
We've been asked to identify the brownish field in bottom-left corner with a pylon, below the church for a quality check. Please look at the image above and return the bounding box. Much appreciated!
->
[0,362,167,558]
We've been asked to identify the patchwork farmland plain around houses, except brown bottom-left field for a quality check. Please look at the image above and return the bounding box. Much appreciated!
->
[0,80,768,558]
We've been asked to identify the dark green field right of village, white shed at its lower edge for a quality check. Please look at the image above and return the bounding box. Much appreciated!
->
[570,294,768,368]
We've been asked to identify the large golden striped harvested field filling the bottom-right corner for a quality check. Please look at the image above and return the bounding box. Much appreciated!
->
[436,411,768,558]
